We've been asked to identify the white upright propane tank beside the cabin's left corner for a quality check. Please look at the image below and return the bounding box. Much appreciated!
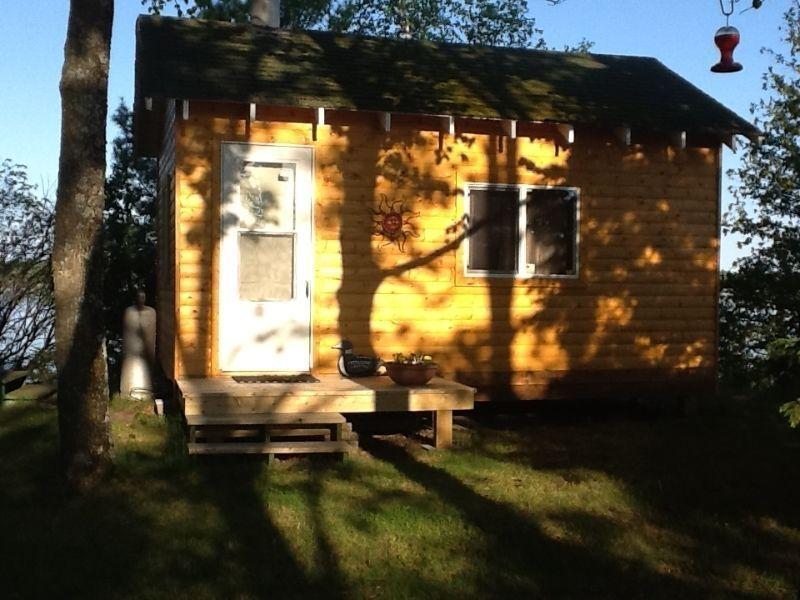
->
[119,292,156,400]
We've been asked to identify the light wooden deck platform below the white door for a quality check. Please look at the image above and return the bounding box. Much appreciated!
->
[177,375,475,448]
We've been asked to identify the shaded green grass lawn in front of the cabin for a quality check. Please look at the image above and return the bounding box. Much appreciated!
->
[0,401,800,599]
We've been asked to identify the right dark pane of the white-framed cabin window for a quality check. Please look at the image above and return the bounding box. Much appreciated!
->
[525,189,578,275]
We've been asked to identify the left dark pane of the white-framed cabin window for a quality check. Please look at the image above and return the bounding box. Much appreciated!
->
[468,189,519,273]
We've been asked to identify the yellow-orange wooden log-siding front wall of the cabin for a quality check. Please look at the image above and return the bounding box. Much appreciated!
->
[167,103,720,396]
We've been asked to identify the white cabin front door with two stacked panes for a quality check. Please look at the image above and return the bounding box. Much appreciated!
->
[218,144,313,373]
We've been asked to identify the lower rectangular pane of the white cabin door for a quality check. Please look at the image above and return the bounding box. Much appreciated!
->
[239,232,294,302]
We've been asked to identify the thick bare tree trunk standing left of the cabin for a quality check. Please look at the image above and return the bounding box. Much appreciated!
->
[53,0,114,491]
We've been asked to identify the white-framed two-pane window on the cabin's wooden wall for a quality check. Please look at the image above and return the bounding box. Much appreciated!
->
[464,183,580,278]
